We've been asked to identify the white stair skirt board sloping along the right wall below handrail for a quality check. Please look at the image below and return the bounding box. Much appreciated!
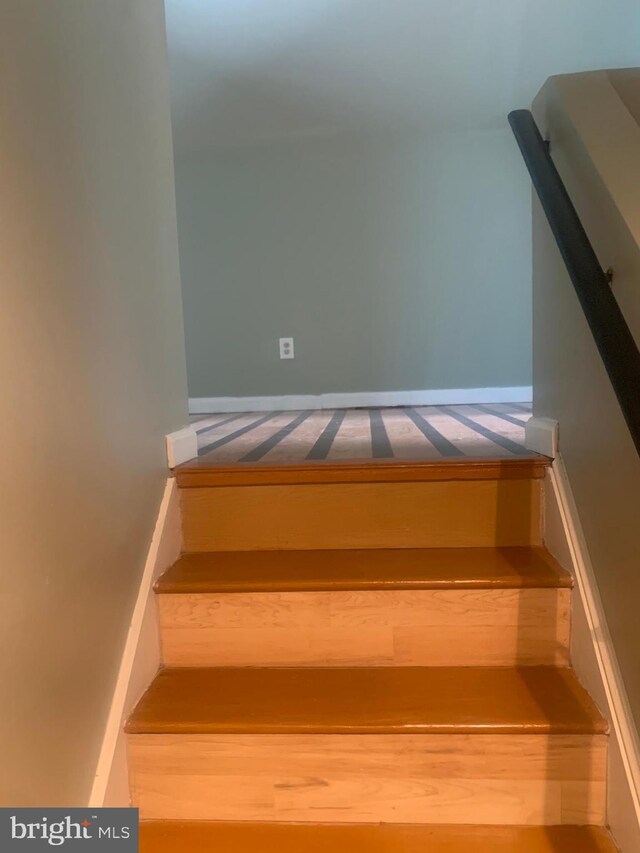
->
[545,456,640,853]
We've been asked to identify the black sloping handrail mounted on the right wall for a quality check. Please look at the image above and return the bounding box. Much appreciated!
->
[509,110,640,454]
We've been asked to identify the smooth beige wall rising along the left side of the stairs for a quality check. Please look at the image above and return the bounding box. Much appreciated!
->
[0,0,186,806]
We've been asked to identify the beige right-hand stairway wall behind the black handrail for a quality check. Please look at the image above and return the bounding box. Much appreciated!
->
[533,70,640,723]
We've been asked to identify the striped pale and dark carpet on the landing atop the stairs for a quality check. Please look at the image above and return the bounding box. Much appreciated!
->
[191,403,531,464]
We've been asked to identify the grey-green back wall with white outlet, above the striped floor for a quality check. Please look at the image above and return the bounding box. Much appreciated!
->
[176,129,531,397]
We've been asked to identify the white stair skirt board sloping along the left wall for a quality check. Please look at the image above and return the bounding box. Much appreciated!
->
[88,477,182,807]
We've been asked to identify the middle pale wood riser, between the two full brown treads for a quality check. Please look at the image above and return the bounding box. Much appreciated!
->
[157,588,571,666]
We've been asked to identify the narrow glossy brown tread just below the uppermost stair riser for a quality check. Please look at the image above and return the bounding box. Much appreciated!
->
[155,547,572,594]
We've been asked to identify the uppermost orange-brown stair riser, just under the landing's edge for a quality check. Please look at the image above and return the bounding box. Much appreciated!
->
[181,479,541,551]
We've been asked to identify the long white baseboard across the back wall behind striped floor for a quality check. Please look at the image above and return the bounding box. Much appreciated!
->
[189,385,533,415]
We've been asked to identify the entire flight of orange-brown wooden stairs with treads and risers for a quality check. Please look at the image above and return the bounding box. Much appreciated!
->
[127,458,615,853]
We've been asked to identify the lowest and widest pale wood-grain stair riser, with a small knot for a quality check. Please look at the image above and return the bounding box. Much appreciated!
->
[128,734,607,825]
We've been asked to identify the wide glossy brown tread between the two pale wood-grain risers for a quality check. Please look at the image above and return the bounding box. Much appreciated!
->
[126,666,607,734]
